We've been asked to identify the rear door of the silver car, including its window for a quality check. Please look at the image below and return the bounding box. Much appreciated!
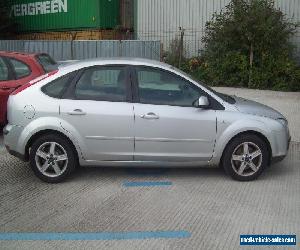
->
[60,65,134,161]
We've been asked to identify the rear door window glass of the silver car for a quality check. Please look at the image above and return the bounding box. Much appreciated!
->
[75,66,127,102]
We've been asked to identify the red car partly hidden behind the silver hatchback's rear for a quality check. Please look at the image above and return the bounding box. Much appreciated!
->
[0,51,57,125]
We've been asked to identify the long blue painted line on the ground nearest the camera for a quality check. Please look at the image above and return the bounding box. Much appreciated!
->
[0,231,191,241]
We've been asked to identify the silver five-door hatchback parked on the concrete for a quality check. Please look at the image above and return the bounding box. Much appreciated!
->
[4,59,290,182]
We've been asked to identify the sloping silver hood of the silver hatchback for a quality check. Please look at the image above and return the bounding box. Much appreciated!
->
[234,96,286,119]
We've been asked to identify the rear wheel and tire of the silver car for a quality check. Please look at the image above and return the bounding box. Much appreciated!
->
[29,134,78,183]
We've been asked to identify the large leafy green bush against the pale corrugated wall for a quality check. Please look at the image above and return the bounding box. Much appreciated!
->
[203,0,300,90]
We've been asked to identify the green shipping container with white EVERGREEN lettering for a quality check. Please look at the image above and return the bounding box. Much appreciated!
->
[10,0,120,32]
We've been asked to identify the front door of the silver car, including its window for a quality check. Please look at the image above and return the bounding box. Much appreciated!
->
[133,66,216,162]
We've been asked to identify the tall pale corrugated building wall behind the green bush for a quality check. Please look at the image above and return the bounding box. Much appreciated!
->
[135,0,300,57]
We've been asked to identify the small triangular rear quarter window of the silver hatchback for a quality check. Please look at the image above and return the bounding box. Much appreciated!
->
[42,72,76,98]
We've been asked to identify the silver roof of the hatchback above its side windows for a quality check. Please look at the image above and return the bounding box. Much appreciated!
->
[61,57,172,70]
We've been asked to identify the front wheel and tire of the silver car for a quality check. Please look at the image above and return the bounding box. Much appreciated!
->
[222,134,270,181]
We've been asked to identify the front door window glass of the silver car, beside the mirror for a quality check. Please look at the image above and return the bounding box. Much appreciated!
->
[136,67,204,107]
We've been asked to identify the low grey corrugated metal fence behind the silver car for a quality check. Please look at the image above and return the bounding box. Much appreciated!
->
[0,40,161,61]
